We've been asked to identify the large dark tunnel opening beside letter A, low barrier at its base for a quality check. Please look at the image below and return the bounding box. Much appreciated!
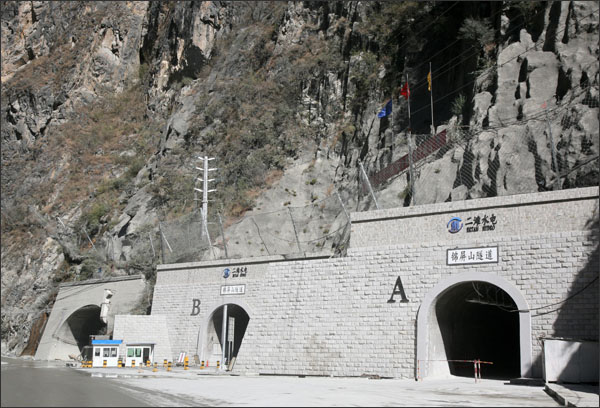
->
[435,281,520,379]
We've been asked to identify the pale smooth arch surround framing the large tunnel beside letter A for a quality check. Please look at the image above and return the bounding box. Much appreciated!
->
[415,272,532,378]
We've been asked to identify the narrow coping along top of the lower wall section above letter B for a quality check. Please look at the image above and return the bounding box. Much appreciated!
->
[156,252,333,272]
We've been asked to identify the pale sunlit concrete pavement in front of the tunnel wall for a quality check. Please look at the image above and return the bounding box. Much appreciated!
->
[70,366,560,407]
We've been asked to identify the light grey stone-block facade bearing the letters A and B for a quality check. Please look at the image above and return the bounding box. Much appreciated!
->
[146,187,599,378]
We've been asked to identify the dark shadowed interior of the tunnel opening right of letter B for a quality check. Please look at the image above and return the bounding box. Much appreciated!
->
[212,303,250,362]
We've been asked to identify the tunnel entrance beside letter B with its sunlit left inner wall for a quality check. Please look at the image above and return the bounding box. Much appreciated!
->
[206,303,250,370]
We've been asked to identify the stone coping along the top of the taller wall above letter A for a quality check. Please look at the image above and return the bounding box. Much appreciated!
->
[350,187,599,224]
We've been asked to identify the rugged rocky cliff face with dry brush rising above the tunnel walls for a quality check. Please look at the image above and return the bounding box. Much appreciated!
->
[1,1,599,354]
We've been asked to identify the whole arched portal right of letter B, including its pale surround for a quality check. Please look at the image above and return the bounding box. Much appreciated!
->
[197,301,252,365]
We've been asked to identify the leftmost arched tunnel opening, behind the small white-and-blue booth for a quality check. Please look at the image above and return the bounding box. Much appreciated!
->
[57,305,106,357]
